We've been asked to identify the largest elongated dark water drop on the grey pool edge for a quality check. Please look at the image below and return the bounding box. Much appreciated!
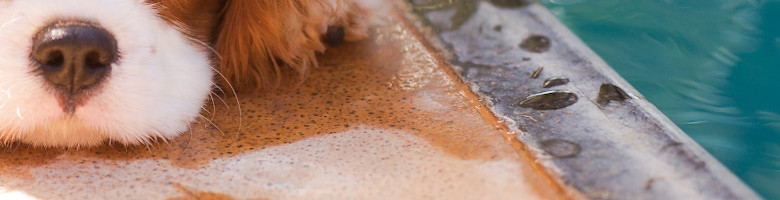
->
[518,91,577,110]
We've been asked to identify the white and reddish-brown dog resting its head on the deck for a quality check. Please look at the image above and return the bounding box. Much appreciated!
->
[0,0,367,147]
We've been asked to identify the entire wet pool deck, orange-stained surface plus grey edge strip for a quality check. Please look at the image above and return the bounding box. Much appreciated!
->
[0,0,758,199]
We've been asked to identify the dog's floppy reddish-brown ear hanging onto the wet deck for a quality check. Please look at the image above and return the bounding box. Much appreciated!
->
[215,0,366,91]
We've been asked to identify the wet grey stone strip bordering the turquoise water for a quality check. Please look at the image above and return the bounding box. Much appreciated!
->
[409,0,760,199]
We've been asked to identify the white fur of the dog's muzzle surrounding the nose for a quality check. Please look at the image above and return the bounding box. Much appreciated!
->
[0,0,213,147]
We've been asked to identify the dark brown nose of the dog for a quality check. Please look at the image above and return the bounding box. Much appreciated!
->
[31,22,118,95]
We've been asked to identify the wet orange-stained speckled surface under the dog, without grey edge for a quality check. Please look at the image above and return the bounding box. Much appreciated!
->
[0,2,567,199]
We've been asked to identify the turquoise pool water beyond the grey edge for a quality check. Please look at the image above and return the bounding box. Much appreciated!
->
[540,0,780,199]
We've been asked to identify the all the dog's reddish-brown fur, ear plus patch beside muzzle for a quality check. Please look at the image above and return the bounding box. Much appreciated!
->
[153,0,367,92]
